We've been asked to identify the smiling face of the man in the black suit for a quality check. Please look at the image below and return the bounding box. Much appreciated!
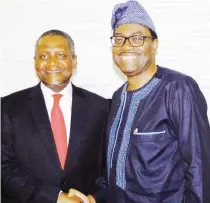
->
[34,35,77,92]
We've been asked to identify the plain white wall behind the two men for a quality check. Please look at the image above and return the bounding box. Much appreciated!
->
[0,0,210,117]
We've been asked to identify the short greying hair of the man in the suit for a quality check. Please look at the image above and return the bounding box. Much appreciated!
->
[36,30,75,56]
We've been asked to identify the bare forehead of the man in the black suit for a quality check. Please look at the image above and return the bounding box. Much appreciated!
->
[37,35,69,49]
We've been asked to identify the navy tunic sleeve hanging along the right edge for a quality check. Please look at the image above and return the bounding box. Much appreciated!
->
[171,78,210,203]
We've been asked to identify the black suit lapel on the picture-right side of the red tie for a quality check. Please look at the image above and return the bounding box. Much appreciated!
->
[64,85,89,172]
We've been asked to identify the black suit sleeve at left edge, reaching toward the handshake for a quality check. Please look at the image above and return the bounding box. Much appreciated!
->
[1,112,60,203]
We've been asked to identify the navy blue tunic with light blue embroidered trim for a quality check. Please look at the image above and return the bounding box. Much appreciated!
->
[107,66,210,203]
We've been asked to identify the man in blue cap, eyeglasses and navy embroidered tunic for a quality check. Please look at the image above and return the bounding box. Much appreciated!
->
[107,0,210,203]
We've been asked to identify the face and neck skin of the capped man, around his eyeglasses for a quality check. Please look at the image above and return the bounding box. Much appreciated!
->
[112,24,158,91]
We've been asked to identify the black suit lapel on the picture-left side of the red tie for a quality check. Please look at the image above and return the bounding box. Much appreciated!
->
[29,85,62,174]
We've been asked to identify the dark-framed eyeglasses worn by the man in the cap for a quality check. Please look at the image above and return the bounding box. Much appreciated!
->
[110,35,155,47]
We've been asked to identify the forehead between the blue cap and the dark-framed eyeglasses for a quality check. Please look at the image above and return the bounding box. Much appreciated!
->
[114,24,150,36]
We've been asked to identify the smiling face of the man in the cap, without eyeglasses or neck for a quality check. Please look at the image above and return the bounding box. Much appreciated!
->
[112,24,157,77]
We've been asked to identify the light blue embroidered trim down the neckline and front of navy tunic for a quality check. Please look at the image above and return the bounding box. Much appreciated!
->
[107,78,160,189]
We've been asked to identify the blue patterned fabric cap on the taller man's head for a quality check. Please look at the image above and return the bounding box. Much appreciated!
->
[111,0,157,34]
